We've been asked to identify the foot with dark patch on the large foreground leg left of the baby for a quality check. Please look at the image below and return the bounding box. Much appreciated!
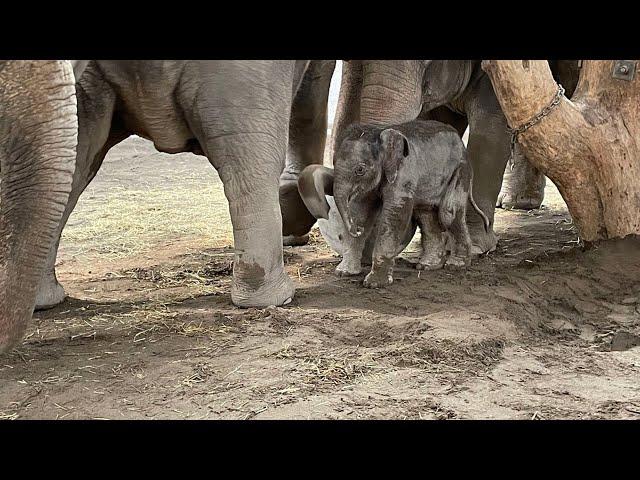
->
[231,262,296,308]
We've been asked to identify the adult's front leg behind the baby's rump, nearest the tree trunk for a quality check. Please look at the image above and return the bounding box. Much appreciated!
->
[465,77,510,255]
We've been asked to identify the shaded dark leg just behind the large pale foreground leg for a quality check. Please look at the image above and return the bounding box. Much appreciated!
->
[280,60,336,245]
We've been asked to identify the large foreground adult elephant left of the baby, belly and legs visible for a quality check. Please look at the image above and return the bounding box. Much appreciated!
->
[0,60,335,348]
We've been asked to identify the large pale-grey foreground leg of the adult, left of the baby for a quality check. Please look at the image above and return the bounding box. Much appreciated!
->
[196,61,295,307]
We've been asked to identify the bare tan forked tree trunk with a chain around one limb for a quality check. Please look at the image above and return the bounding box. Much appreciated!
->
[483,60,640,241]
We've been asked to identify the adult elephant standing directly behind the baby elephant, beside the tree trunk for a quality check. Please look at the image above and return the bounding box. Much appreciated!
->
[332,60,577,260]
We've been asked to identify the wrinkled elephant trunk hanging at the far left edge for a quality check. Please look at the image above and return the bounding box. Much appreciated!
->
[0,61,78,353]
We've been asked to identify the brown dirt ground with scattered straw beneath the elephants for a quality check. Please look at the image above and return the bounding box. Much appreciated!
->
[0,138,640,419]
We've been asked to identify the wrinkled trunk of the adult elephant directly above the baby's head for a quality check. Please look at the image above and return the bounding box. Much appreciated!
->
[360,60,424,126]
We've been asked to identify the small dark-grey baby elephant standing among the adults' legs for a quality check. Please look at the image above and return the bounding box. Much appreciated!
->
[333,120,489,288]
